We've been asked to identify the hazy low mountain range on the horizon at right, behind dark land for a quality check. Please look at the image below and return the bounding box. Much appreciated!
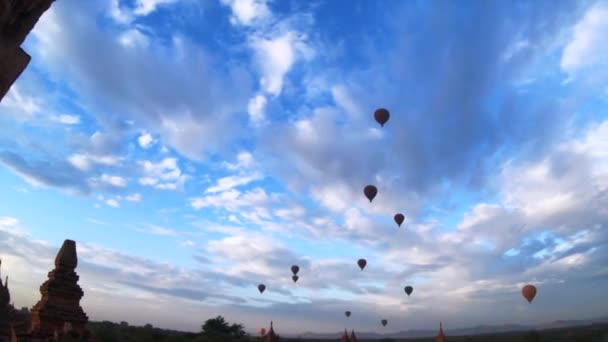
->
[285,317,608,340]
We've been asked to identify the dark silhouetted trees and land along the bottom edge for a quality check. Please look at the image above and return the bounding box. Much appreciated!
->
[89,316,608,342]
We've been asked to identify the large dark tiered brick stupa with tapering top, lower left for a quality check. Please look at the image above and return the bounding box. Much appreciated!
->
[30,240,89,337]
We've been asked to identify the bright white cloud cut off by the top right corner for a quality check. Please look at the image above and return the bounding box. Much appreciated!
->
[561,2,608,77]
